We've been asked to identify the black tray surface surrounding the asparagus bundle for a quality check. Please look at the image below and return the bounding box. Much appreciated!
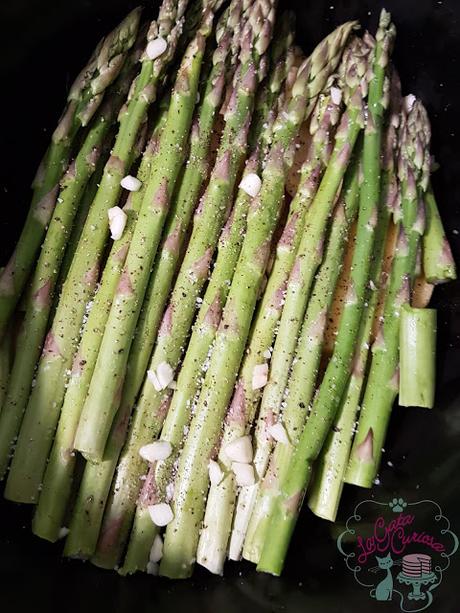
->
[0,0,460,613]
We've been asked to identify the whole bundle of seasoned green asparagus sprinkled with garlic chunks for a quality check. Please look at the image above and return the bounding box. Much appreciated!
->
[0,0,456,578]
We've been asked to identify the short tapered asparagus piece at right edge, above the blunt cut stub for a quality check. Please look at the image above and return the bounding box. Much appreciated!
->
[423,184,457,283]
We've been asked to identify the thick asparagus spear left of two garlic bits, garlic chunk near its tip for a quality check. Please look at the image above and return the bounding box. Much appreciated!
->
[5,0,187,502]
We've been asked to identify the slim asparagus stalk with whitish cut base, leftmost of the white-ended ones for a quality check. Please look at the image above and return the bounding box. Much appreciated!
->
[197,82,339,573]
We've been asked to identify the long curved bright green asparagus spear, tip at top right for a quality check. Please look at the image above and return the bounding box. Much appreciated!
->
[258,11,394,574]
